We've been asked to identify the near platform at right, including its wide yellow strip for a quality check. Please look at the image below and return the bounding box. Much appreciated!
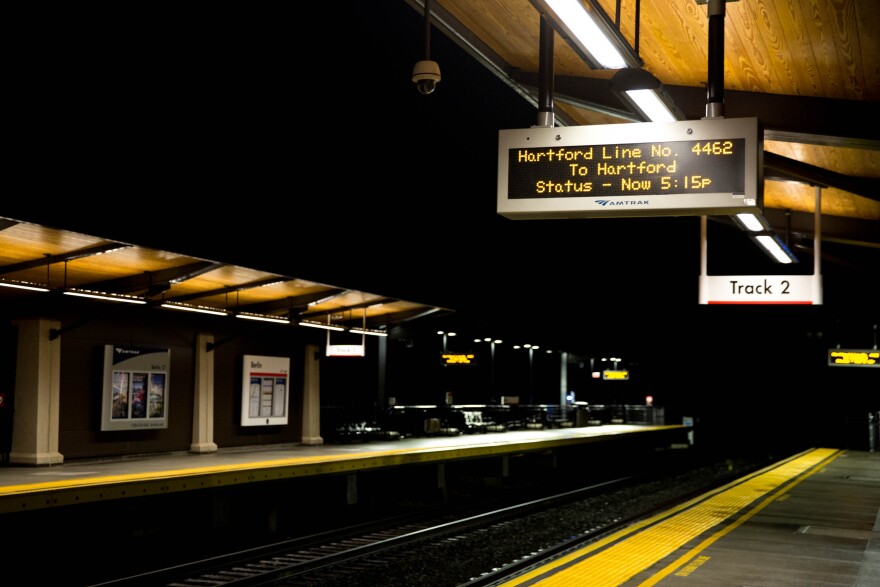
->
[497,448,880,587]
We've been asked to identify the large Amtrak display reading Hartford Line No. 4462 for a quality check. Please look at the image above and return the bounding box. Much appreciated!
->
[498,118,763,219]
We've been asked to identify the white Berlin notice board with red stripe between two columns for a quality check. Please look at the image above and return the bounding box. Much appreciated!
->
[241,355,290,426]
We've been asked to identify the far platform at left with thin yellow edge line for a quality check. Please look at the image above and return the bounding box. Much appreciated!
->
[0,424,690,514]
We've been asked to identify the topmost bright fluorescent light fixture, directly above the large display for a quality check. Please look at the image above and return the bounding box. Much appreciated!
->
[532,0,642,69]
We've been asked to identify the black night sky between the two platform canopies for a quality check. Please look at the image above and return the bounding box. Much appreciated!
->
[8,0,876,360]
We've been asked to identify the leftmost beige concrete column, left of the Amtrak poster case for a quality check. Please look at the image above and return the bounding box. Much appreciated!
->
[9,318,64,465]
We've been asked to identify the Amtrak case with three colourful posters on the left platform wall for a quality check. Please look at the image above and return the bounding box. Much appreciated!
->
[101,345,171,430]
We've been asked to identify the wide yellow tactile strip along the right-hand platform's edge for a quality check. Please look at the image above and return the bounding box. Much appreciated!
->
[499,448,843,587]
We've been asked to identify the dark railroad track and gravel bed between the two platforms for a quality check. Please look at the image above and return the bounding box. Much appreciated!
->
[93,454,766,587]
